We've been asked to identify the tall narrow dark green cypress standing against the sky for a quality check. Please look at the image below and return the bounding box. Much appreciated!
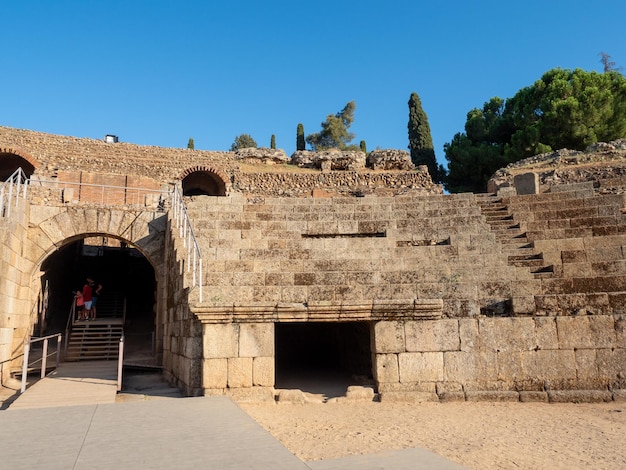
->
[408,92,438,183]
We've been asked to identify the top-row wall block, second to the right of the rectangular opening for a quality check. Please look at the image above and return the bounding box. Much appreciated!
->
[404,319,461,352]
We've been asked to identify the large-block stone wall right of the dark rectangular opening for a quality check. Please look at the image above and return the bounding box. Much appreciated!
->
[373,315,626,402]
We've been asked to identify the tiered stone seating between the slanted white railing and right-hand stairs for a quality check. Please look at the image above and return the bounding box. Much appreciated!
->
[187,194,537,316]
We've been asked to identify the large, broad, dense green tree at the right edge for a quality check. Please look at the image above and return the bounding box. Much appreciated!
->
[444,69,626,192]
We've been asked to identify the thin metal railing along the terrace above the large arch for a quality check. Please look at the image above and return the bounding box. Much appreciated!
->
[28,178,170,209]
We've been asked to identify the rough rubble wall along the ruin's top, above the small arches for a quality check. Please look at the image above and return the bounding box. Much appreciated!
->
[0,126,443,197]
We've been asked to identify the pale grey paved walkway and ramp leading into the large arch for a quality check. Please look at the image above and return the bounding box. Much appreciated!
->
[0,361,463,470]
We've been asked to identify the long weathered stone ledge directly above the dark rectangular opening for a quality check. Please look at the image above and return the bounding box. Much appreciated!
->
[191,299,443,323]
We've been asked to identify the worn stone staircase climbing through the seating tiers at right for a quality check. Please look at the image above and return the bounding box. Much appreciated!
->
[476,194,553,277]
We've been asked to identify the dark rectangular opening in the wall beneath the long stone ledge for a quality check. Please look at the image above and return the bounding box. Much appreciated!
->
[275,322,373,398]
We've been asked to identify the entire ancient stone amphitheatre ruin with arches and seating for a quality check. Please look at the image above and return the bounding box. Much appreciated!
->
[0,127,626,402]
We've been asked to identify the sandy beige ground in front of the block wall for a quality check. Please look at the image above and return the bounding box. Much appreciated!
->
[240,402,626,470]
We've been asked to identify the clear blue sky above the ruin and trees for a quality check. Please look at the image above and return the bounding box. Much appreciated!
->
[0,0,626,169]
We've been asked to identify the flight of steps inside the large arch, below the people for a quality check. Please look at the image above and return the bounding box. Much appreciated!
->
[65,318,124,361]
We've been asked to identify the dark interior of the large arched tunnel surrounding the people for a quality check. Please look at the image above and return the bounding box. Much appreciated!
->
[35,236,157,366]
